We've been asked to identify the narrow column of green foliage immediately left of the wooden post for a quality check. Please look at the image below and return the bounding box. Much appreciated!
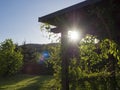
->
[48,45,61,90]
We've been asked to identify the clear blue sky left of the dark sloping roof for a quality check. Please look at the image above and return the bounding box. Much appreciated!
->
[0,0,83,45]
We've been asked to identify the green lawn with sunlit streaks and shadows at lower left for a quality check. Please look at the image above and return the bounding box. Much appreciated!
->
[0,75,52,90]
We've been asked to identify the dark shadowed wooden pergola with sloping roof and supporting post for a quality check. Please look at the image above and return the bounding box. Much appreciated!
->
[38,0,120,90]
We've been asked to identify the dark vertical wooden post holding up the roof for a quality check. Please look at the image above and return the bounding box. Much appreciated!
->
[61,31,69,90]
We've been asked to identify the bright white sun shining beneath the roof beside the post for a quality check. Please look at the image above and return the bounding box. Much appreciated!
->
[68,30,80,41]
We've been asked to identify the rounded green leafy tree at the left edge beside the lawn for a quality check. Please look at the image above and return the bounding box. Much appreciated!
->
[0,39,23,76]
